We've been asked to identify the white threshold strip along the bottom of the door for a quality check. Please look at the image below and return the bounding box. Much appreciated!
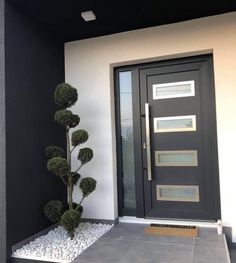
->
[119,216,217,228]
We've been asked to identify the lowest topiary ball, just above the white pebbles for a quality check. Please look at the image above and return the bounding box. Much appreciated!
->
[61,209,81,239]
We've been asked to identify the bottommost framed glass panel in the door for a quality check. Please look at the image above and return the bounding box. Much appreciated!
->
[156,185,199,202]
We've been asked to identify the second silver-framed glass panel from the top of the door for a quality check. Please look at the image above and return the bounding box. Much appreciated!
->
[154,115,196,133]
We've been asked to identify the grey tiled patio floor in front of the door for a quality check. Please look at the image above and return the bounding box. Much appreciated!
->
[75,223,228,263]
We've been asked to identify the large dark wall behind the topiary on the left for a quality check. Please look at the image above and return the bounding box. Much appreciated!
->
[4,2,66,263]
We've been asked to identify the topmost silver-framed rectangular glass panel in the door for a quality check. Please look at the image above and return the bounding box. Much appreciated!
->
[152,80,195,100]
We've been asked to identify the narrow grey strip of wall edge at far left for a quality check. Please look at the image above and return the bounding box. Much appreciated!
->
[0,0,6,262]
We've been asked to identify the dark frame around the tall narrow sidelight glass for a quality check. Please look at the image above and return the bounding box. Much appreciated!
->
[113,65,144,218]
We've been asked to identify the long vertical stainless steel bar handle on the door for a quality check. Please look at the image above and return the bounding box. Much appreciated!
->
[145,103,152,181]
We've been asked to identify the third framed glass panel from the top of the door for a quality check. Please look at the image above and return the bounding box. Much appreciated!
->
[155,150,198,166]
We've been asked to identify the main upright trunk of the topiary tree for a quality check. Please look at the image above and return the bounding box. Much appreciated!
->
[66,127,73,210]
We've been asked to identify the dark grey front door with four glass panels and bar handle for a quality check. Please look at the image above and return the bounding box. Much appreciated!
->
[137,56,220,220]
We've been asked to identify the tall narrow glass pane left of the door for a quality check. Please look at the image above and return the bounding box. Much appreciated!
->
[119,71,136,211]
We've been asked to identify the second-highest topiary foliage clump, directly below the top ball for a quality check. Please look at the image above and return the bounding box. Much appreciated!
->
[54,110,80,128]
